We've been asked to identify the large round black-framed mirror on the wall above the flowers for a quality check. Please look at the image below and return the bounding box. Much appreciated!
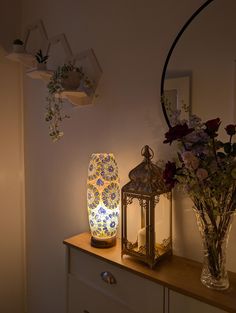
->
[161,0,236,127]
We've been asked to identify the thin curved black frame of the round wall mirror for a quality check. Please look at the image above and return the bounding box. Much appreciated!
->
[161,0,214,128]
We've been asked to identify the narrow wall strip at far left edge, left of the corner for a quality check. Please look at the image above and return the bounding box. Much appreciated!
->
[0,0,25,313]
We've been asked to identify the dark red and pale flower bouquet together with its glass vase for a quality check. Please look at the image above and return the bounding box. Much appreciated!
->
[163,106,236,290]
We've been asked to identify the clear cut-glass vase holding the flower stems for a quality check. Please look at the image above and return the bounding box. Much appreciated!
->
[195,209,234,290]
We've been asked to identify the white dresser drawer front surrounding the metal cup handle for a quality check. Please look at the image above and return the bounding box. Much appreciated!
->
[69,248,164,313]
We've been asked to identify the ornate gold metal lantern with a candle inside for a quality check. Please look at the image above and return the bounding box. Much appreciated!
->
[121,146,172,268]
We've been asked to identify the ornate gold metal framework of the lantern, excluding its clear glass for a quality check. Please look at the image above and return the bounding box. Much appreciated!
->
[121,146,172,268]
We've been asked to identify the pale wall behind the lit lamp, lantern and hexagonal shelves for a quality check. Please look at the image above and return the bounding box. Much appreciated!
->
[19,0,235,313]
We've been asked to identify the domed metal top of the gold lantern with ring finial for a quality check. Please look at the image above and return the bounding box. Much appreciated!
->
[122,145,167,195]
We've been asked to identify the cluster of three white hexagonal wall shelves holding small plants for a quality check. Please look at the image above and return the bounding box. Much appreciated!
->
[6,20,102,106]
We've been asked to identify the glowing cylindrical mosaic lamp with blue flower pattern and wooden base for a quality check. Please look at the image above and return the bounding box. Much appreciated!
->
[87,153,120,248]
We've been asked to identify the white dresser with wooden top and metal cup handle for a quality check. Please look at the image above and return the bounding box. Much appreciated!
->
[64,233,236,313]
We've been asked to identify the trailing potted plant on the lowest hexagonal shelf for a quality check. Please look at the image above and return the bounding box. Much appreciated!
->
[45,62,94,142]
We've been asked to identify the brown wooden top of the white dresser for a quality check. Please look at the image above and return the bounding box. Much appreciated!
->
[64,233,236,313]
